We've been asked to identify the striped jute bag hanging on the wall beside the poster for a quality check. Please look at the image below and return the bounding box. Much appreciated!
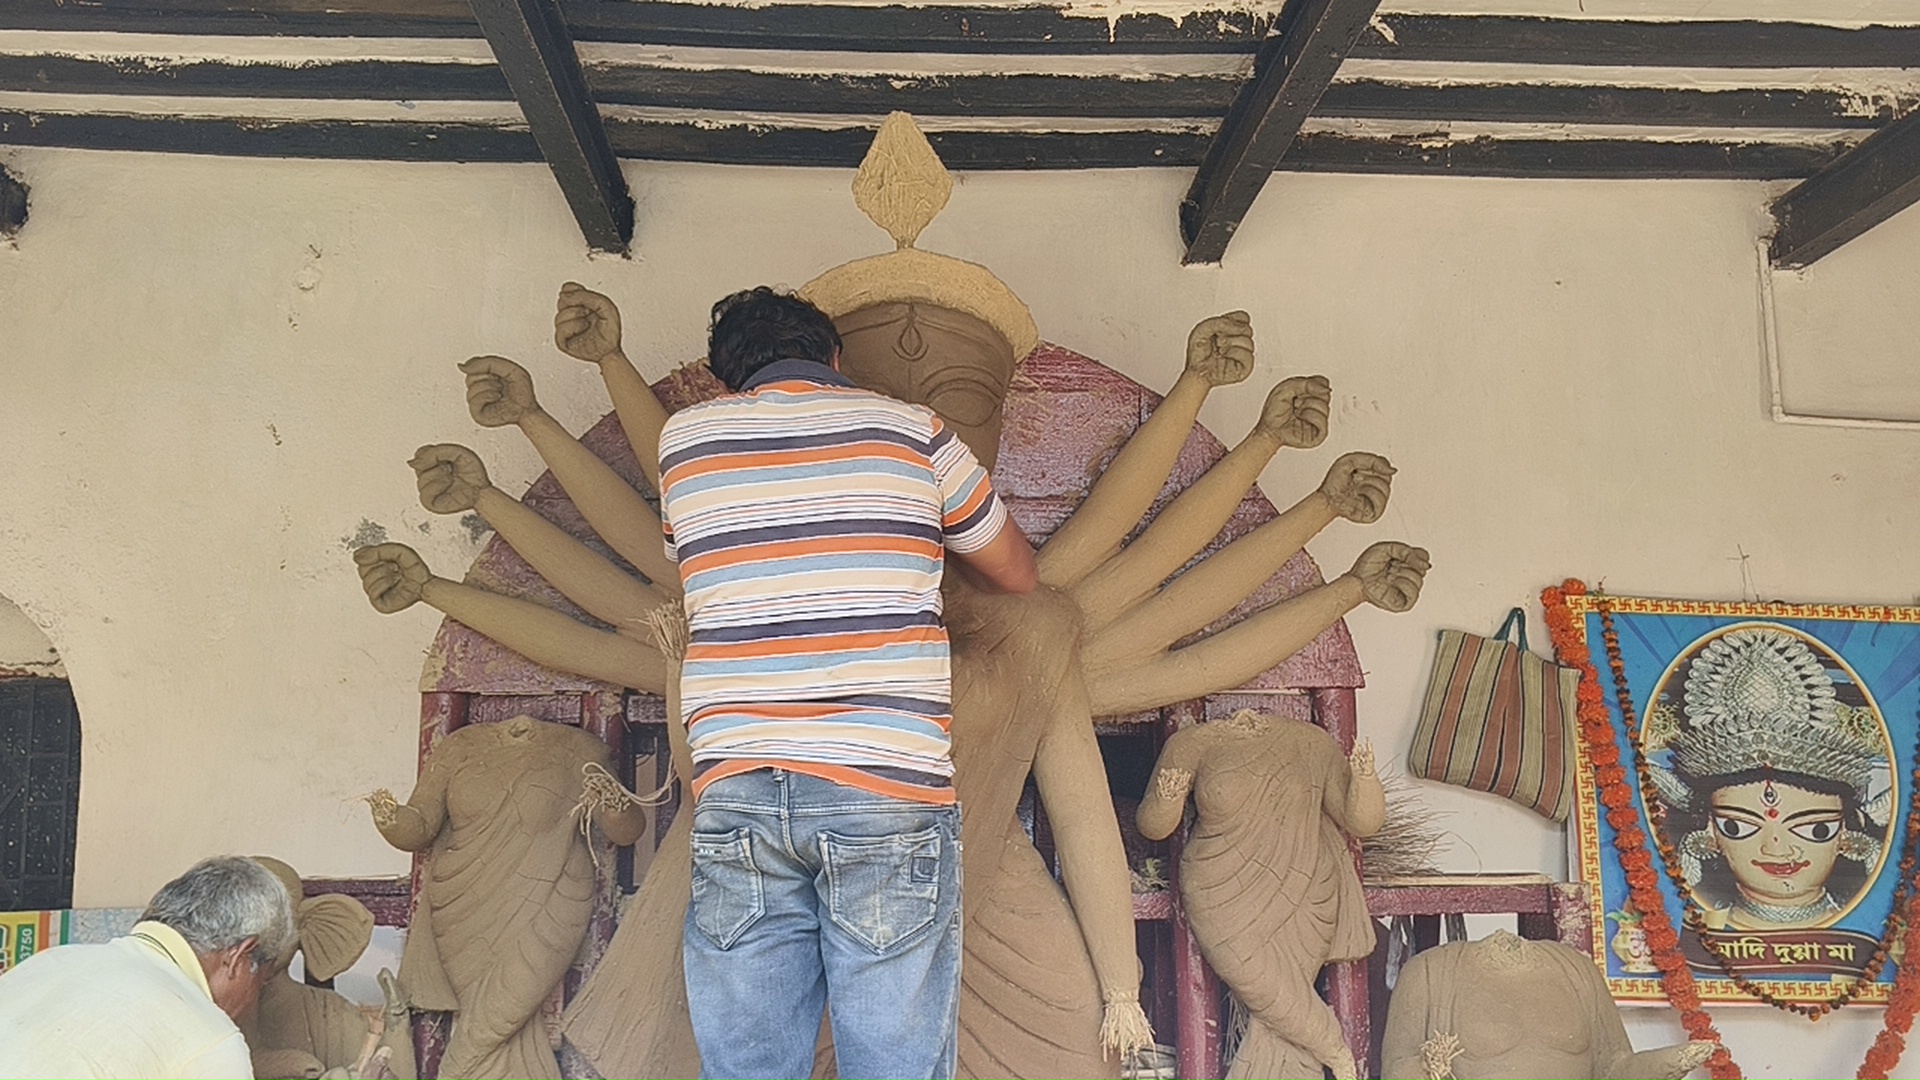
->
[1407,607,1580,821]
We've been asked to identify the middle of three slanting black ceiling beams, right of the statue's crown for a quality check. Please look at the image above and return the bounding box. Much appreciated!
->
[1181,0,1380,263]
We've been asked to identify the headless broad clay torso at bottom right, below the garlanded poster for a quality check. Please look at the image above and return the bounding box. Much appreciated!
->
[1380,930,1718,1080]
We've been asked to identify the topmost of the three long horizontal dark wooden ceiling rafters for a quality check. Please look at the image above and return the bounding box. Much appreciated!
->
[0,0,1920,67]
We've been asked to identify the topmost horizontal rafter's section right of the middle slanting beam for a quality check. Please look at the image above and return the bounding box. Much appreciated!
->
[1352,13,1920,67]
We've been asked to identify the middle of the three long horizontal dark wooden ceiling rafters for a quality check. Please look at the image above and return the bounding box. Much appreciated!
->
[0,54,1916,129]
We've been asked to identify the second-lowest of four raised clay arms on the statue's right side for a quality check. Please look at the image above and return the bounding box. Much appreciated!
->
[1087,454,1394,667]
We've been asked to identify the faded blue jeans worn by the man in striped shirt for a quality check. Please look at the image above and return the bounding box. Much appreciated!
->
[685,769,960,1080]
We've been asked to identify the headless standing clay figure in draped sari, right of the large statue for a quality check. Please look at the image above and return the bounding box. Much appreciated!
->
[1139,709,1386,1080]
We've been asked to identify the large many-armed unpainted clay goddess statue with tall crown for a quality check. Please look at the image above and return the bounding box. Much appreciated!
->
[355,113,1427,1080]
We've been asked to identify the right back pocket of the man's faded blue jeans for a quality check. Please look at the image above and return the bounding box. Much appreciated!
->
[820,826,950,953]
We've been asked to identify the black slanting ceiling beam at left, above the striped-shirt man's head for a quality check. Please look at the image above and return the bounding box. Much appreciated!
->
[470,0,634,252]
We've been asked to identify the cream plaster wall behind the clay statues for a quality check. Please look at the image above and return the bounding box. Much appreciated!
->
[0,150,1920,1080]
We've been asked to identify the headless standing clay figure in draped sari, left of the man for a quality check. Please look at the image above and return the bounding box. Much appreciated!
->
[371,717,645,1080]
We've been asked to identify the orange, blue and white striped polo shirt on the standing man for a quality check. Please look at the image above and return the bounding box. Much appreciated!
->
[660,359,1006,803]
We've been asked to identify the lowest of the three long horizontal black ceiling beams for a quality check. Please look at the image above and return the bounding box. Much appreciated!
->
[0,110,1845,181]
